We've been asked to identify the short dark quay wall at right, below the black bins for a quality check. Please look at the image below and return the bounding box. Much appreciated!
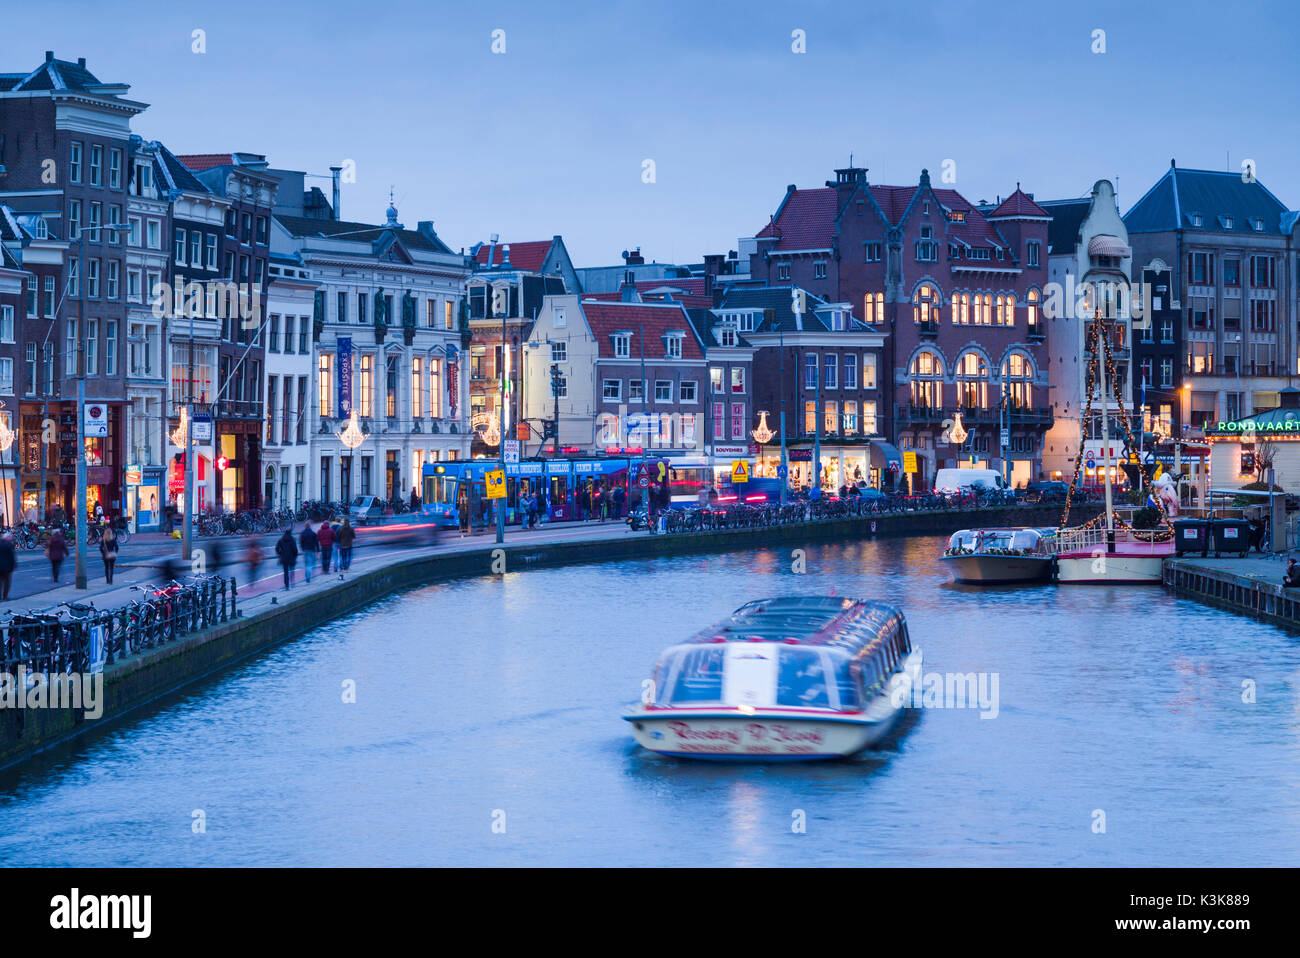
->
[1162,558,1300,632]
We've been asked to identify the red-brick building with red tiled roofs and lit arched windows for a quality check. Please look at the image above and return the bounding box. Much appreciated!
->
[750,168,1052,485]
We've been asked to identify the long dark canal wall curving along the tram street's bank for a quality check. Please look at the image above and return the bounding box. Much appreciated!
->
[0,507,1091,768]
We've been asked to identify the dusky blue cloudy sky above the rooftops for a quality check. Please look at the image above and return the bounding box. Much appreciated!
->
[12,0,1300,265]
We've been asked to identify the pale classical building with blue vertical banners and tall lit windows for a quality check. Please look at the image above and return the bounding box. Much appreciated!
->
[272,198,471,500]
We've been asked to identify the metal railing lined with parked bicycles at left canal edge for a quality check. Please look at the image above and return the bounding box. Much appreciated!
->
[0,576,237,676]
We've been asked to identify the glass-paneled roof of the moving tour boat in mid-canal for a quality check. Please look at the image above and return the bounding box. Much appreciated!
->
[686,595,904,655]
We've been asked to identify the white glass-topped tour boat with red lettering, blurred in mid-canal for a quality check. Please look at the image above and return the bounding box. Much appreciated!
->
[623,595,920,762]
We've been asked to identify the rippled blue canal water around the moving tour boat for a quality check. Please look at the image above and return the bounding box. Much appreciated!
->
[0,538,1300,866]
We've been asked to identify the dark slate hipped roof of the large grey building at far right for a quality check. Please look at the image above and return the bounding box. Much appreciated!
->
[1125,166,1287,235]
